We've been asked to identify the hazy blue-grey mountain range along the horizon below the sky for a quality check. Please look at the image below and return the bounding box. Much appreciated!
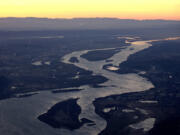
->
[0,17,180,31]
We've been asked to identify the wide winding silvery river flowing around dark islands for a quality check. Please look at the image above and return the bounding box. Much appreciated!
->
[0,36,179,135]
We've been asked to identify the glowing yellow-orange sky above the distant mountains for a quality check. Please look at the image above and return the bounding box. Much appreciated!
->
[0,0,180,20]
